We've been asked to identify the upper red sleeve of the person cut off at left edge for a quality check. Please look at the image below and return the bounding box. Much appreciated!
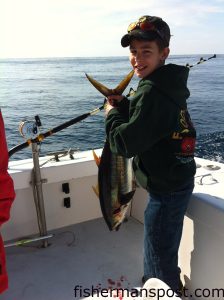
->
[0,110,15,226]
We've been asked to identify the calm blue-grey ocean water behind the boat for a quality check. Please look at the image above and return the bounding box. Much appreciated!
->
[0,54,224,162]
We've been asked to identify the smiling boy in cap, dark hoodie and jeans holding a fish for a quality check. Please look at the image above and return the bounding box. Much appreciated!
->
[106,16,196,291]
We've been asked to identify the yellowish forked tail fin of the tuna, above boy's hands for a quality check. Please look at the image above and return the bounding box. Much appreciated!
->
[85,70,134,97]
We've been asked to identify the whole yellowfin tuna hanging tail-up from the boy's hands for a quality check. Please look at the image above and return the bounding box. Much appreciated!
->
[86,71,136,230]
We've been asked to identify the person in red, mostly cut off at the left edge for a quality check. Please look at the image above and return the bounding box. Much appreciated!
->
[0,109,15,294]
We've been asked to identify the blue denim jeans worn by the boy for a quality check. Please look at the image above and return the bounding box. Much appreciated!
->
[144,179,194,291]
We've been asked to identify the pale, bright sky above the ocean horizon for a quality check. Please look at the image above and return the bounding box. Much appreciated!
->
[0,0,224,58]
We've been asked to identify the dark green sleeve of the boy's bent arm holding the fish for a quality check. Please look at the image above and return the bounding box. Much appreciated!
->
[106,88,176,157]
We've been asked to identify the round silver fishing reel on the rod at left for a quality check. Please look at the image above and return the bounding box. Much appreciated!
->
[19,115,42,139]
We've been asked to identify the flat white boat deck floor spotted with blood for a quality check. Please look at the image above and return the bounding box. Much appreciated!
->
[0,218,143,300]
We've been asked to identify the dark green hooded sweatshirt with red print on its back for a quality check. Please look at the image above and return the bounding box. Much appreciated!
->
[106,64,196,193]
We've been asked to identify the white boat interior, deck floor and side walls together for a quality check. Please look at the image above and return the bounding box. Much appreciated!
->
[0,149,224,300]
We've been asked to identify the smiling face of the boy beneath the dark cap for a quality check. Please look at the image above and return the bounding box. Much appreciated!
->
[129,40,169,78]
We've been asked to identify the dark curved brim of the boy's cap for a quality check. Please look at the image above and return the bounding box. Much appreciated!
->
[121,30,158,47]
